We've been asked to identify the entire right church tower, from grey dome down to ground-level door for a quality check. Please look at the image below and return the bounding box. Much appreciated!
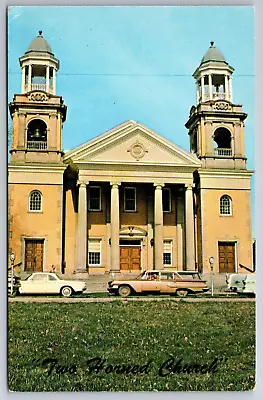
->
[185,42,253,274]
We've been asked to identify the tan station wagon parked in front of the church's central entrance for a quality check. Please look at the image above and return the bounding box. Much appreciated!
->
[107,270,209,297]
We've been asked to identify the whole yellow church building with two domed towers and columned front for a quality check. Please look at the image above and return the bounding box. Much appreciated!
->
[8,31,253,276]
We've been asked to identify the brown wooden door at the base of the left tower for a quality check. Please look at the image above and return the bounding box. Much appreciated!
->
[25,239,44,272]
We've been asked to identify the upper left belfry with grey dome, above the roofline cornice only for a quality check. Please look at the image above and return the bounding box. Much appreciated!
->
[9,31,67,164]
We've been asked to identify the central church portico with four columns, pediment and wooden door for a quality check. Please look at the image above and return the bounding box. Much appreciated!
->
[66,121,199,273]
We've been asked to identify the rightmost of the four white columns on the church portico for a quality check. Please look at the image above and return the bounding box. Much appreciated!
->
[185,185,195,271]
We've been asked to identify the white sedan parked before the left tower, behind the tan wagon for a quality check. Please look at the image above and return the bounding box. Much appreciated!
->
[19,272,86,297]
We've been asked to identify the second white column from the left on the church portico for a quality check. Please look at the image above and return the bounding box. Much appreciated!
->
[110,182,120,272]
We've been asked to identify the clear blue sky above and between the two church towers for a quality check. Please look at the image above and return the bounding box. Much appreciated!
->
[8,6,254,233]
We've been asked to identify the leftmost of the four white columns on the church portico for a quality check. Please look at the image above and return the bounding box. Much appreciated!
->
[76,181,88,272]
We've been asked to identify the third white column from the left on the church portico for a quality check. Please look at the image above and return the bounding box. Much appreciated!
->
[154,183,164,269]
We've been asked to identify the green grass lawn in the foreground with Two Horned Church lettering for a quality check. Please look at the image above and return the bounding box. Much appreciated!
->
[8,299,255,392]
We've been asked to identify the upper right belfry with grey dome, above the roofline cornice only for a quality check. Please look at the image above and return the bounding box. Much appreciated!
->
[185,42,247,169]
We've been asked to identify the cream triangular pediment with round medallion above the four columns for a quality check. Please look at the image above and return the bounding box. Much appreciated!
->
[64,121,201,168]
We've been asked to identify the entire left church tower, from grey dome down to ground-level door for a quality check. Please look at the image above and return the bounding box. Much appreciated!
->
[8,31,67,274]
